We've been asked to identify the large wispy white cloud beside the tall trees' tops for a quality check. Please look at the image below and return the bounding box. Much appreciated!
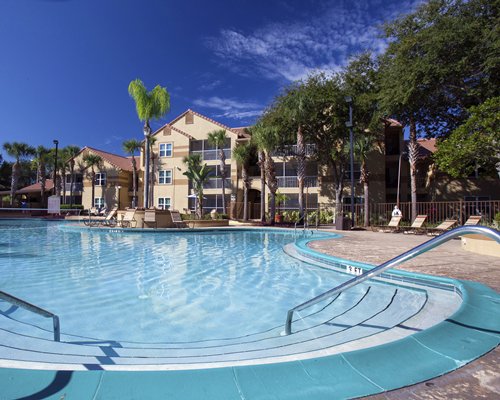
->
[206,0,422,81]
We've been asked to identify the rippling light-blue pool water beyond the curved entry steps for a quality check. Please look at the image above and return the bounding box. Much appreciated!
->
[0,221,376,343]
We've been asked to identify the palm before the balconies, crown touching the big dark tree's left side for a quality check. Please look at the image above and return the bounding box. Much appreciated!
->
[251,120,278,225]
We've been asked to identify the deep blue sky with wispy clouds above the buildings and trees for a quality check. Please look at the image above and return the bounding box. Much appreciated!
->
[0,0,422,159]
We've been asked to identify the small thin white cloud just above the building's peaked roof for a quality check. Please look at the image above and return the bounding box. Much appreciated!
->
[194,96,264,120]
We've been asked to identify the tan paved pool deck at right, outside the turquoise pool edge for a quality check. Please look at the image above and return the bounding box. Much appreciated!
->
[309,231,500,400]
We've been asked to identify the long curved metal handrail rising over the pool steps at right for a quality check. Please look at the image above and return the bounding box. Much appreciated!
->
[285,226,500,335]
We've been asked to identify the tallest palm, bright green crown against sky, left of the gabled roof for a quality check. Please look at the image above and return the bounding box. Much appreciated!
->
[128,79,170,208]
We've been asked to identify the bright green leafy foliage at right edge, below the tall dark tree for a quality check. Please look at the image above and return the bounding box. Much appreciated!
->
[434,97,500,177]
